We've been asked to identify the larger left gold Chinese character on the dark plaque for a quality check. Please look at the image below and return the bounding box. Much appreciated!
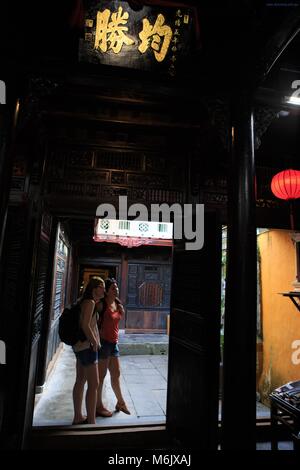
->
[94,7,134,54]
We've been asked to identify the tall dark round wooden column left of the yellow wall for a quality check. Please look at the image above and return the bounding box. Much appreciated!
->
[222,93,256,450]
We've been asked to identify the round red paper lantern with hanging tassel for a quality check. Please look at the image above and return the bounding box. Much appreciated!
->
[271,170,300,230]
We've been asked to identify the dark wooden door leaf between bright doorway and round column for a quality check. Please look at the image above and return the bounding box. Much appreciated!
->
[167,213,221,450]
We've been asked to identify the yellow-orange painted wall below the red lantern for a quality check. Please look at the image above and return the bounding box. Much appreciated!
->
[258,230,300,402]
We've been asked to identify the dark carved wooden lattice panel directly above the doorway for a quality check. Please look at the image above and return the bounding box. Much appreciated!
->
[46,147,185,204]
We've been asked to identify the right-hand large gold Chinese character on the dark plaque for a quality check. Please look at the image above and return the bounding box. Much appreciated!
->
[138,14,172,62]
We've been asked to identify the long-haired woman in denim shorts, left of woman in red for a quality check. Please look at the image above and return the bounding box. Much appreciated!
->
[73,277,105,424]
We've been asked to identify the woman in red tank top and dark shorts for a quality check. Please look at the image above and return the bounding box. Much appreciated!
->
[96,279,130,418]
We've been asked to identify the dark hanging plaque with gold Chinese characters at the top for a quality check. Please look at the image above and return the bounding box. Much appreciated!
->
[79,1,194,75]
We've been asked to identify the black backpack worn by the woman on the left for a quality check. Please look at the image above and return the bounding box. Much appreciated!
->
[58,302,86,346]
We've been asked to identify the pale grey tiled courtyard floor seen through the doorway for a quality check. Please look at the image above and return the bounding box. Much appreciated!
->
[33,346,270,426]
